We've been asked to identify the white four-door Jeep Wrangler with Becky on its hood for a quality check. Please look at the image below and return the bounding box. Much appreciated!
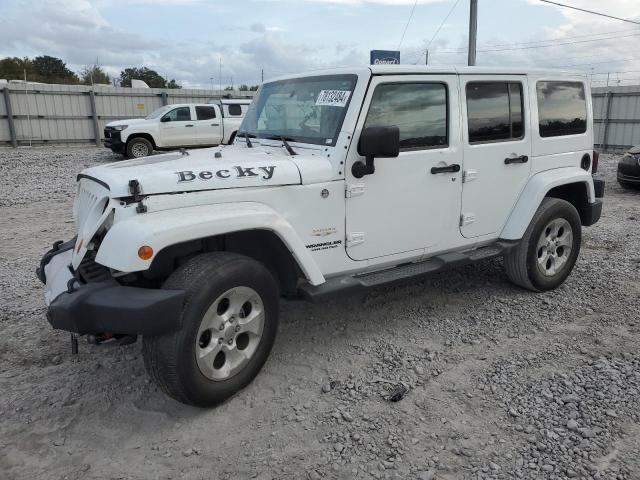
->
[38,65,604,406]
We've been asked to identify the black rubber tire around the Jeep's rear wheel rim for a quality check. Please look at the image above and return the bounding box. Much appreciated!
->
[504,198,582,292]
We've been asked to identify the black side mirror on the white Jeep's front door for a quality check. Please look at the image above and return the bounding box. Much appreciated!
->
[351,125,400,178]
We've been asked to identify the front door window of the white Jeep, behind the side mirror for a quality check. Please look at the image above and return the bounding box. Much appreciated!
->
[364,83,448,150]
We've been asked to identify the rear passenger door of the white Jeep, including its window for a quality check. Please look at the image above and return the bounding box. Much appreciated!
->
[460,75,531,238]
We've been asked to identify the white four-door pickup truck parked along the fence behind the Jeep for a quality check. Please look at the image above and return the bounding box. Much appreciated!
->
[104,99,251,158]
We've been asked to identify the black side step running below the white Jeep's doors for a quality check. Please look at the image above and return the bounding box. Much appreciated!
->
[300,241,518,302]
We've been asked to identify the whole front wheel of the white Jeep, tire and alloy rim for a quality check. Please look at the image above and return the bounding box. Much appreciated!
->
[143,252,278,407]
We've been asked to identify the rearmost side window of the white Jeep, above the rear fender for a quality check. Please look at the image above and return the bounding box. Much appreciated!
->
[536,82,587,137]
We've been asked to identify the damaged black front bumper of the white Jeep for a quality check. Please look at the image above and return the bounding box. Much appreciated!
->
[38,240,184,335]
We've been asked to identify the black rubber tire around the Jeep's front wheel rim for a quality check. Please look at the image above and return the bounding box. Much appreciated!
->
[142,252,279,407]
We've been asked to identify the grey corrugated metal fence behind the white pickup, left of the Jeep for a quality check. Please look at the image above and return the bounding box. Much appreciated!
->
[0,83,254,145]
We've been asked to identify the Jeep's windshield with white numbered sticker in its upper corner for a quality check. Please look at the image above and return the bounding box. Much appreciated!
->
[238,75,358,145]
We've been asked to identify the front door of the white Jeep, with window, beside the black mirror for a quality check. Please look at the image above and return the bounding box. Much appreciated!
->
[346,75,462,260]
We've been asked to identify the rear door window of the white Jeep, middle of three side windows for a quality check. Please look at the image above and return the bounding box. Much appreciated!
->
[466,82,524,143]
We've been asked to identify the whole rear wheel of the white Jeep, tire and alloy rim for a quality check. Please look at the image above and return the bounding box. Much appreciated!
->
[504,198,582,292]
